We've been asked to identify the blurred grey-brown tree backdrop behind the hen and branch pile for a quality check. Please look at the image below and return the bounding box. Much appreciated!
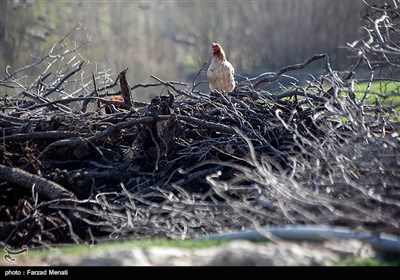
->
[0,0,364,99]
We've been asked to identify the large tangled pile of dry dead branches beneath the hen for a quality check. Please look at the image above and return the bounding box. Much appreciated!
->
[0,2,400,246]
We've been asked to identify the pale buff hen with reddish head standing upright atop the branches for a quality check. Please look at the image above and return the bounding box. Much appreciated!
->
[207,43,235,94]
